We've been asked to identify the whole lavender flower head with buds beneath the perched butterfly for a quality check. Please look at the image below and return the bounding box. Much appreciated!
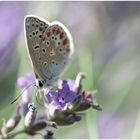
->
[45,73,101,125]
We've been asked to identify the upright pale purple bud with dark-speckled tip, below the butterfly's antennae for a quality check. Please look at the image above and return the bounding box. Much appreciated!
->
[24,103,37,127]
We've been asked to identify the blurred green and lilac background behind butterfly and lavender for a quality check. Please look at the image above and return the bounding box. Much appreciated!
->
[0,1,140,139]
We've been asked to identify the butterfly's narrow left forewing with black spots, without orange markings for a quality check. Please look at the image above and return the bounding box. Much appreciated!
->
[25,16,49,78]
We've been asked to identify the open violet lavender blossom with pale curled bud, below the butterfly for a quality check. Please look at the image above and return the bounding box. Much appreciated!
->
[47,73,85,110]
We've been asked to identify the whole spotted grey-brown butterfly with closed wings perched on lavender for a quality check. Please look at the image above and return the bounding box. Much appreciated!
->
[24,15,74,89]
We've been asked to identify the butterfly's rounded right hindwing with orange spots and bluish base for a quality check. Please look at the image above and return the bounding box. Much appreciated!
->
[41,22,73,83]
